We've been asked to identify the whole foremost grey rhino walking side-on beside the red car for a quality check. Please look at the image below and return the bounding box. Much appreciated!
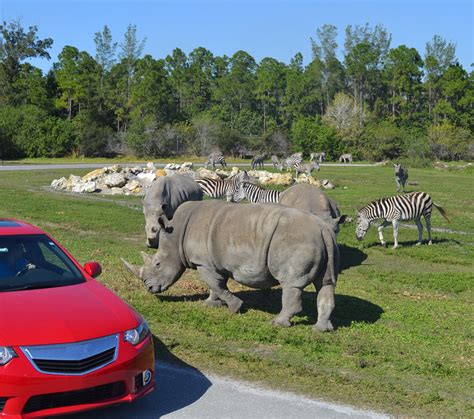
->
[122,200,339,331]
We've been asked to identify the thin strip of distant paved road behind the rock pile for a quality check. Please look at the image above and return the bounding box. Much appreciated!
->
[0,162,376,171]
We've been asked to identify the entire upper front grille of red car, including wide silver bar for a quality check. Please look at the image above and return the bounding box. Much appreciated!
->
[21,335,118,375]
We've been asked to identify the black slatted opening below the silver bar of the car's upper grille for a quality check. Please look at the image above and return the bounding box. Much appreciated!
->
[33,348,115,374]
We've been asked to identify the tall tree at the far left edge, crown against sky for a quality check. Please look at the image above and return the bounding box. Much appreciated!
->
[0,20,53,104]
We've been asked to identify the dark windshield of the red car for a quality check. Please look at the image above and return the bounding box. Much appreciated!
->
[0,234,85,292]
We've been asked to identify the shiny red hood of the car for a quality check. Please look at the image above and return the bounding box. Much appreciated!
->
[0,280,140,346]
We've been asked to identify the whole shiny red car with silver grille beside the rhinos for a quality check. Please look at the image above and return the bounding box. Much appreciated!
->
[0,219,154,418]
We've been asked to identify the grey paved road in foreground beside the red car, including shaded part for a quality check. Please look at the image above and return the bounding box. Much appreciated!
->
[68,364,388,419]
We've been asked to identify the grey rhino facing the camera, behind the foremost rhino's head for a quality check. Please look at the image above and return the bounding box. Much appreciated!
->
[143,174,203,248]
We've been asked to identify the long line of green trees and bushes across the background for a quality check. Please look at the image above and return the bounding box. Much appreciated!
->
[0,21,474,162]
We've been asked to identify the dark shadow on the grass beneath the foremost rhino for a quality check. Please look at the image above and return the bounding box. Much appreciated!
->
[158,288,384,328]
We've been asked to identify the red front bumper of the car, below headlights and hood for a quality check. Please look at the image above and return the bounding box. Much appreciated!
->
[0,335,154,419]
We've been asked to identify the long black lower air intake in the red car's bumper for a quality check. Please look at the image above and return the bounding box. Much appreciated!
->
[23,381,125,413]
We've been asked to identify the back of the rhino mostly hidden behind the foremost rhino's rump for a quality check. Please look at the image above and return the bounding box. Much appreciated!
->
[279,183,343,233]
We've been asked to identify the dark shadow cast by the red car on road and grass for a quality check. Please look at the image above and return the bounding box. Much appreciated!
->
[67,336,212,419]
